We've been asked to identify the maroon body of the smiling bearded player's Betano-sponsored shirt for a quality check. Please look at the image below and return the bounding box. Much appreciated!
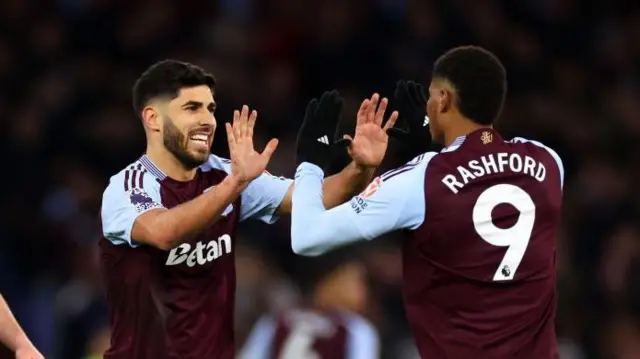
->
[100,169,240,359]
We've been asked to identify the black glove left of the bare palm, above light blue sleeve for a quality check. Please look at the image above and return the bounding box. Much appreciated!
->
[296,90,349,169]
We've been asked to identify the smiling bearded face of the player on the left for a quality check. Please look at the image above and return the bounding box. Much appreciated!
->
[162,86,216,168]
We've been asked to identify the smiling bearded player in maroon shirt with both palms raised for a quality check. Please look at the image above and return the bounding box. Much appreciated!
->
[100,60,397,359]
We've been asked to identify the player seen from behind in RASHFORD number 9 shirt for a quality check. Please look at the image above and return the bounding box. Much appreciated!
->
[291,46,564,359]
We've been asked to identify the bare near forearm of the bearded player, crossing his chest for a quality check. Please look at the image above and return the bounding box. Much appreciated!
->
[148,176,246,250]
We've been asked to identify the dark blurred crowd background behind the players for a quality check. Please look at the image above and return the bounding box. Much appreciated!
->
[0,0,640,359]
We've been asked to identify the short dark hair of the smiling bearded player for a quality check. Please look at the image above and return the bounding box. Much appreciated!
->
[132,60,216,116]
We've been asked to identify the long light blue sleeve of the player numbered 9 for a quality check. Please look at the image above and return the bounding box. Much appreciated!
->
[291,152,436,256]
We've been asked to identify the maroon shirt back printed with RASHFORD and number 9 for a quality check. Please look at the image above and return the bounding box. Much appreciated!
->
[403,130,563,359]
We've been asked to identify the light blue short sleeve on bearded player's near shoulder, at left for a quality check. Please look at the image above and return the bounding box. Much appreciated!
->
[100,169,164,247]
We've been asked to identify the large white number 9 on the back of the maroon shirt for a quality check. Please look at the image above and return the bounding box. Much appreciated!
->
[473,184,536,281]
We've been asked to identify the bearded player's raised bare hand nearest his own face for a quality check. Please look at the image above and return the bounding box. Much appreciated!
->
[225,105,278,183]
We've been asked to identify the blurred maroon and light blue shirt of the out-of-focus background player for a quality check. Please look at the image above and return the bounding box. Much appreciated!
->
[240,310,379,359]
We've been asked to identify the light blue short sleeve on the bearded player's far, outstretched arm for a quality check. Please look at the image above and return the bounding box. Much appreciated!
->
[208,155,293,224]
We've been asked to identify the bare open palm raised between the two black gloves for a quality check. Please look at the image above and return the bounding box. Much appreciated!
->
[346,94,398,167]
